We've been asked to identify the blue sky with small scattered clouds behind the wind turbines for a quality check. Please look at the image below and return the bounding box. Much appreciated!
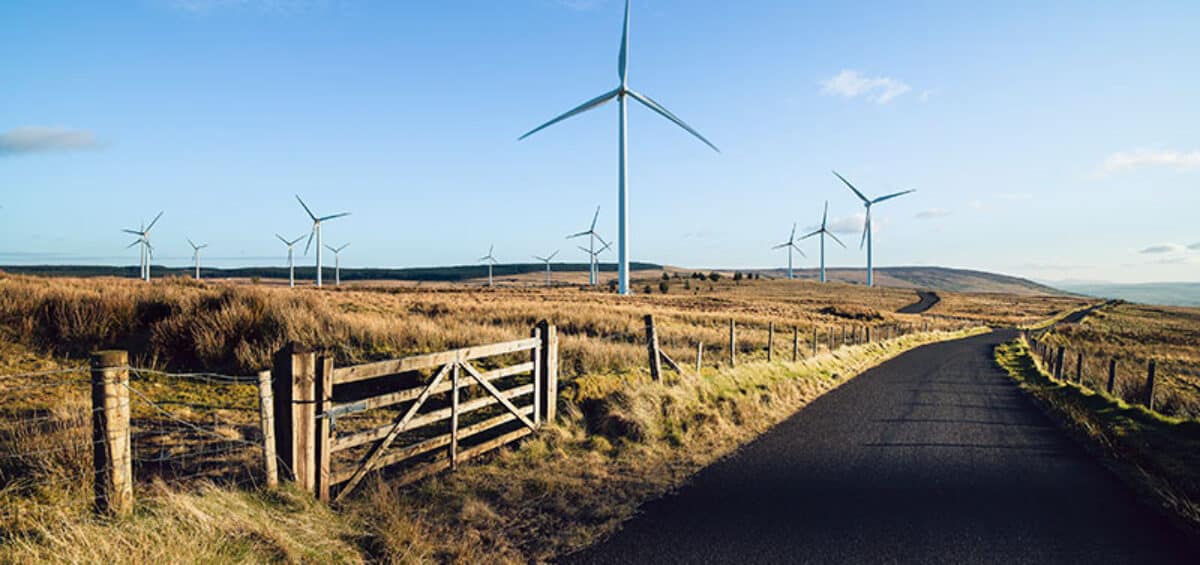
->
[0,0,1200,282]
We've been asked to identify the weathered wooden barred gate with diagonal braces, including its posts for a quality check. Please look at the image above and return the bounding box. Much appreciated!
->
[276,323,558,500]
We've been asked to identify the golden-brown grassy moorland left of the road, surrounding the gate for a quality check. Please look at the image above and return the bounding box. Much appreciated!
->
[0,275,1085,563]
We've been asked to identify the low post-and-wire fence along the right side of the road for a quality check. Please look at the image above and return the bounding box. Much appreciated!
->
[1022,330,1200,417]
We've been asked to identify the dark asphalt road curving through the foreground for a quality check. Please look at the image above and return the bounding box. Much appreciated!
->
[563,331,1200,565]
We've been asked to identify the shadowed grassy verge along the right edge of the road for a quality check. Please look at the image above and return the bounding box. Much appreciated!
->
[996,342,1200,533]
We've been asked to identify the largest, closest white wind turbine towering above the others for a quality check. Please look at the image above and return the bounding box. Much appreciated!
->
[520,0,720,294]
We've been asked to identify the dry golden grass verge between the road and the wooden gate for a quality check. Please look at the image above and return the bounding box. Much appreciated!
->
[0,332,984,563]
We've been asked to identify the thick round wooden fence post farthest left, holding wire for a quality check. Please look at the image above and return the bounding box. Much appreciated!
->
[91,350,133,517]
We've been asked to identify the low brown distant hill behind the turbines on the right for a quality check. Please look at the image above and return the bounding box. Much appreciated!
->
[739,266,1068,296]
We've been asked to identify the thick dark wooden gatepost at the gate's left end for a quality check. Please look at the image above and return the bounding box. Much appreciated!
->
[271,342,317,494]
